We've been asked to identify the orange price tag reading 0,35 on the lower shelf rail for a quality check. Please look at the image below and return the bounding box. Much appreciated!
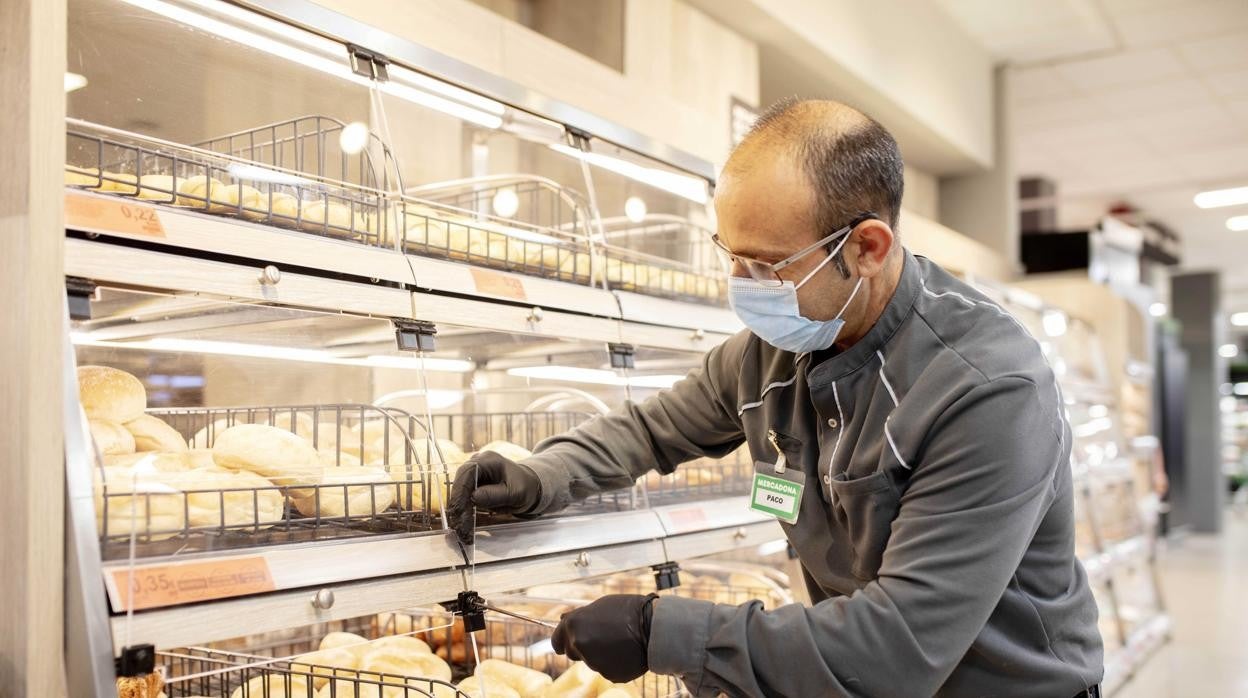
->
[112,557,277,611]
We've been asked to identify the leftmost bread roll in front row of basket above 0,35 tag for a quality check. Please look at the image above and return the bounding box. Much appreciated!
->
[91,466,186,541]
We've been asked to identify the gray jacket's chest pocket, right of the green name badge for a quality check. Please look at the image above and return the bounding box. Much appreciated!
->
[831,471,900,581]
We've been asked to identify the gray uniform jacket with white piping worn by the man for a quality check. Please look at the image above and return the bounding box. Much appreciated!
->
[525,252,1103,698]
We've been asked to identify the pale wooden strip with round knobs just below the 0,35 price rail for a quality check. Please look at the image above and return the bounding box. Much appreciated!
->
[112,541,665,647]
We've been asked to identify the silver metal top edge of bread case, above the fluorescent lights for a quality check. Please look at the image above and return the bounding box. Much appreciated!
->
[232,0,715,182]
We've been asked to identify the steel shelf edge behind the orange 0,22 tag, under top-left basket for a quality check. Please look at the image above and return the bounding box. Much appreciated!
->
[65,189,416,285]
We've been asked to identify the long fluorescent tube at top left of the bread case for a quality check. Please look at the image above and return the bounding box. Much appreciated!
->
[116,0,503,129]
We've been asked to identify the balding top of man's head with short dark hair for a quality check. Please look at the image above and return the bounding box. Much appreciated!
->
[724,100,904,235]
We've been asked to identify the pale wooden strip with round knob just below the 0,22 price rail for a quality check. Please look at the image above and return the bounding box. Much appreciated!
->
[65,238,412,317]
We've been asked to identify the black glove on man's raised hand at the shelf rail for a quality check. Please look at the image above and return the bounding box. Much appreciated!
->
[447,451,542,546]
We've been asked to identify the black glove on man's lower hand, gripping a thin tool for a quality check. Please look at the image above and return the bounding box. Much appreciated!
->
[550,594,659,683]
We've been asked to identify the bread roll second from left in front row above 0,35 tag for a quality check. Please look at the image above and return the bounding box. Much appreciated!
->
[158,468,286,528]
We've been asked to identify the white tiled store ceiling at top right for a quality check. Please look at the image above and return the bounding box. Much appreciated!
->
[935,0,1248,329]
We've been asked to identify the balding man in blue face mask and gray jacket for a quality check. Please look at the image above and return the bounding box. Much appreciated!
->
[449,101,1102,698]
